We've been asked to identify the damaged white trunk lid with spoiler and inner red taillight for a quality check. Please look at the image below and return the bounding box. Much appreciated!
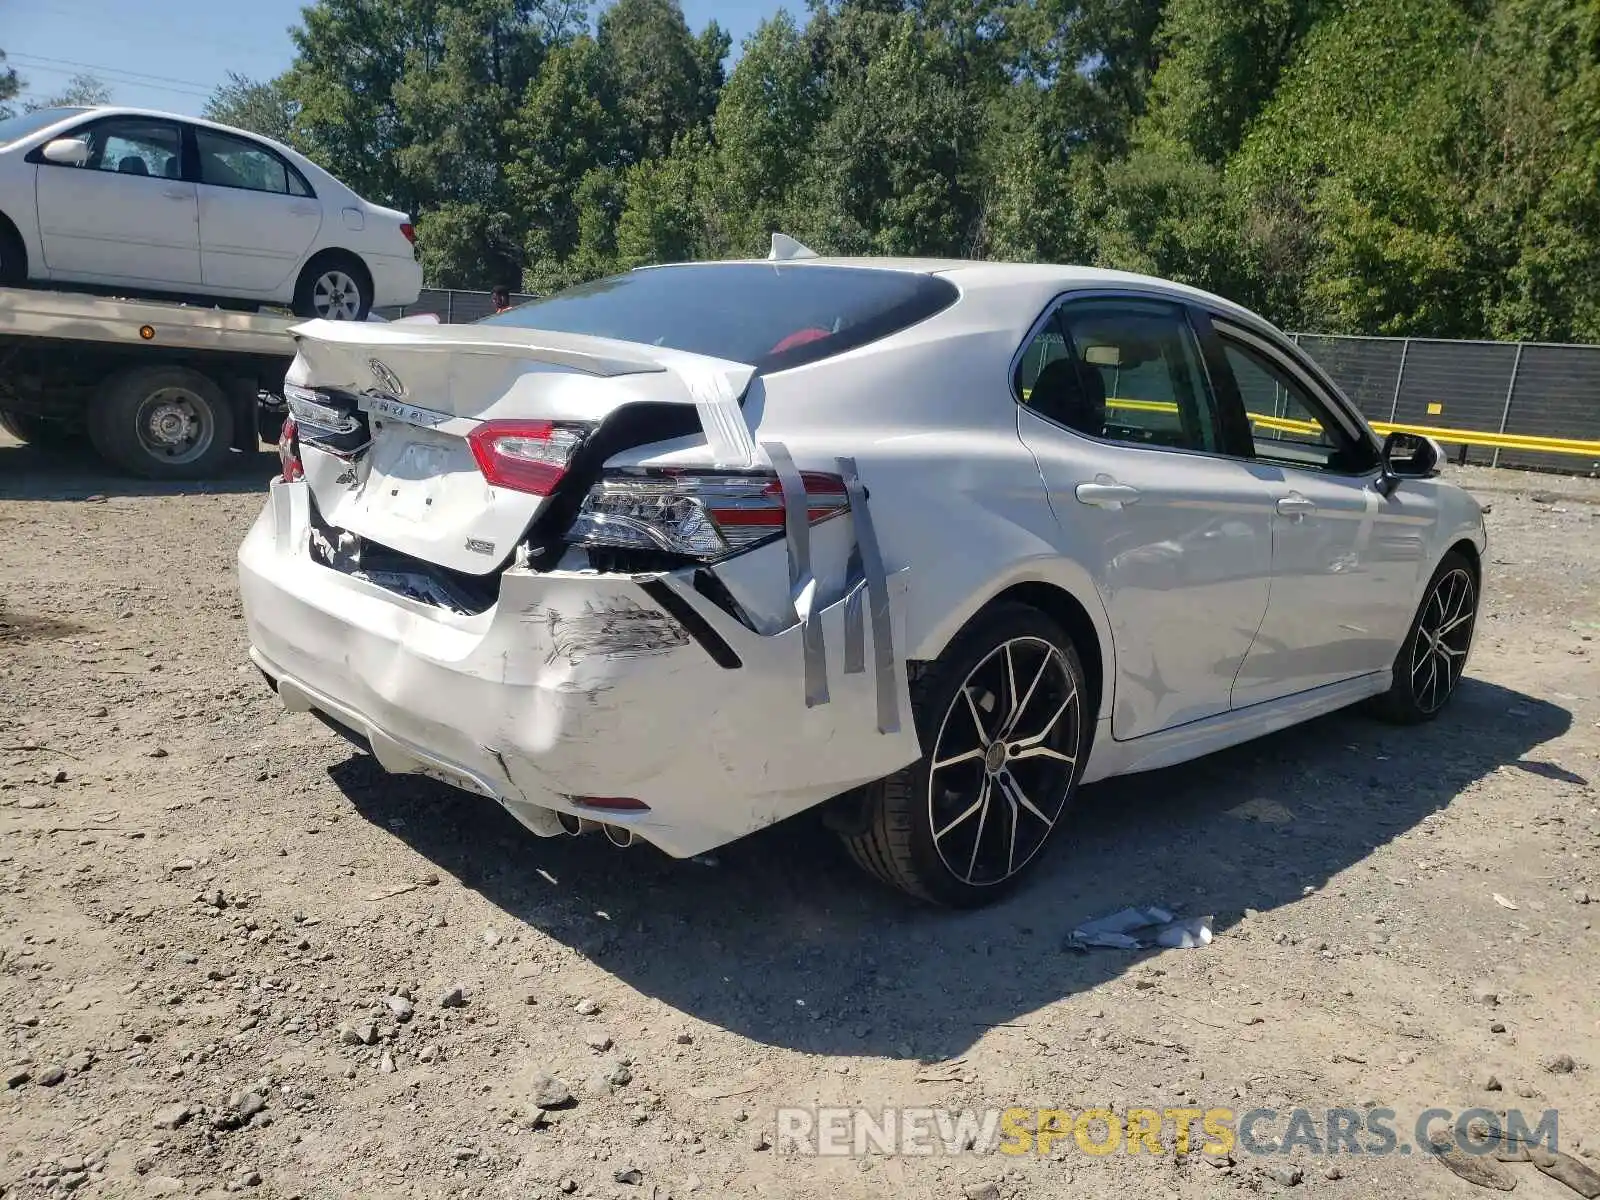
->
[286,322,757,574]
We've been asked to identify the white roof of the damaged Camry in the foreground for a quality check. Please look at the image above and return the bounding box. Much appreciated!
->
[642,254,1272,328]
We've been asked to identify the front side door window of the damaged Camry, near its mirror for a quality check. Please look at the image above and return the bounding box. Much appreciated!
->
[1222,336,1368,470]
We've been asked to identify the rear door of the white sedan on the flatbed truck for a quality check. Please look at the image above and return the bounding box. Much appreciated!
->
[194,126,322,296]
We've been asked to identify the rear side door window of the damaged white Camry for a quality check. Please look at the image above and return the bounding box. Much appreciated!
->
[1014,301,1222,451]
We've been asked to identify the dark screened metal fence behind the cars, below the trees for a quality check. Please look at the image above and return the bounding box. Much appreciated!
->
[379,288,1600,475]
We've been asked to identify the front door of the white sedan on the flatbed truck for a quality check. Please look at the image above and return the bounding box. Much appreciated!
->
[29,117,200,288]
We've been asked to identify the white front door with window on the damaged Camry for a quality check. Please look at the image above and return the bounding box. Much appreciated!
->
[1214,317,1438,707]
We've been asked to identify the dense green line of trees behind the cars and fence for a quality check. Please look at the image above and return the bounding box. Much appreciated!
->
[259,0,1600,341]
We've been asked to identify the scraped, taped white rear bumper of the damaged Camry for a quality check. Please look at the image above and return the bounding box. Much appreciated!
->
[238,482,920,856]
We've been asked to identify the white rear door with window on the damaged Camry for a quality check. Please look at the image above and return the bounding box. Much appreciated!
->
[1013,296,1272,741]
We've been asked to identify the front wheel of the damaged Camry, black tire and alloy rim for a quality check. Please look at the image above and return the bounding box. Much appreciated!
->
[1371,550,1478,725]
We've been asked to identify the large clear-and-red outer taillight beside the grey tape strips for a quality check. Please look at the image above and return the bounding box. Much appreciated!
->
[568,470,850,562]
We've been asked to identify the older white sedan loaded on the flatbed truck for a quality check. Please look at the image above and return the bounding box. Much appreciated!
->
[0,107,422,320]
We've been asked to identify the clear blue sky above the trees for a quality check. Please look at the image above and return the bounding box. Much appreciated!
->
[0,0,768,114]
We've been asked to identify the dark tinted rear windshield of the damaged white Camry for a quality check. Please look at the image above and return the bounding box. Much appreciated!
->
[470,262,960,371]
